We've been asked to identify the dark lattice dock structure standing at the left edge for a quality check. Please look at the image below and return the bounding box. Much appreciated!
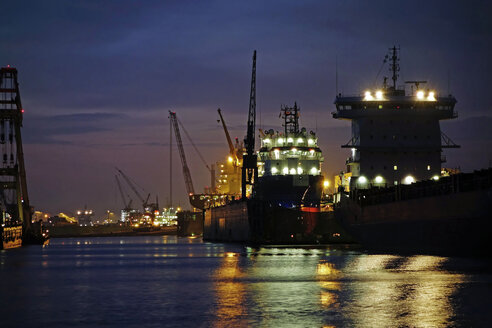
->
[0,66,32,249]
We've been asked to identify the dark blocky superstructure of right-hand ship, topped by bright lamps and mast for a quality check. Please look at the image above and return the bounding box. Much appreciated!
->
[333,47,459,189]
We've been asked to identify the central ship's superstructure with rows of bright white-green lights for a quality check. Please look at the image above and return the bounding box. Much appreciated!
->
[254,103,323,207]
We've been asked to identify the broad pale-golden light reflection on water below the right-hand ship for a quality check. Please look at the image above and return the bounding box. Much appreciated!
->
[345,255,463,327]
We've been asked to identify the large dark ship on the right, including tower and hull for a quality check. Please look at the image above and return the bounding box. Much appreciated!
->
[333,47,492,255]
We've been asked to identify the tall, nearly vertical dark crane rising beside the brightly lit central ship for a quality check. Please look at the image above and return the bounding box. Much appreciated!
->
[241,50,258,198]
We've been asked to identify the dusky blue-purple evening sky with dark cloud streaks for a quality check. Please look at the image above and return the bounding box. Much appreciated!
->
[0,0,492,216]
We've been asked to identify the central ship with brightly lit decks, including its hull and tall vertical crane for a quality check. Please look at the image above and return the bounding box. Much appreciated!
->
[203,52,343,244]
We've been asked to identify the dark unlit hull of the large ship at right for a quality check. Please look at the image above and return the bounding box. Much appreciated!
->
[335,184,492,256]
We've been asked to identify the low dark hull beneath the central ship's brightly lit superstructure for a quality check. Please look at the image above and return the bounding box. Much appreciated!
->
[204,199,353,245]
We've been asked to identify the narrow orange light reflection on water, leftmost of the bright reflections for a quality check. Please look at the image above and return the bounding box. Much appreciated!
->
[213,252,246,327]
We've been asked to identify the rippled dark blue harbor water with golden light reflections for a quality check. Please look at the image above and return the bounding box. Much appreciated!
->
[0,236,492,327]
